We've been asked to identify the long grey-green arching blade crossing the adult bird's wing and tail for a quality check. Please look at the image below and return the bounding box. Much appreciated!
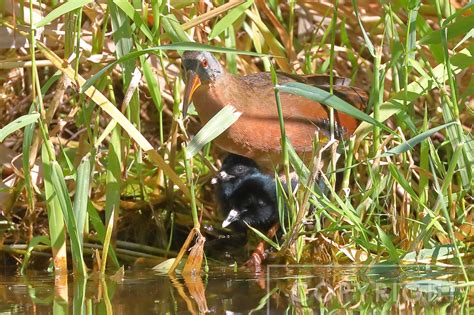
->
[276,82,394,134]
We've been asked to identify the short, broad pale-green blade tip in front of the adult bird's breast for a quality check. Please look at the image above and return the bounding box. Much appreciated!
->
[186,105,242,159]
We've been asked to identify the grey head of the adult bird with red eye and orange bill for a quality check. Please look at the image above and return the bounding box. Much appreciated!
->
[182,51,224,117]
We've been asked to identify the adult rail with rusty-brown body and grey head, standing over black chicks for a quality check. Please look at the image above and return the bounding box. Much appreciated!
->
[182,51,367,163]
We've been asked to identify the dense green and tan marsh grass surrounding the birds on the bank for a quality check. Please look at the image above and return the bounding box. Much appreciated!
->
[0,1,474,278]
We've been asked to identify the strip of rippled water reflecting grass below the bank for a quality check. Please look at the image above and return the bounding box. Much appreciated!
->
[0,265,474,314]
